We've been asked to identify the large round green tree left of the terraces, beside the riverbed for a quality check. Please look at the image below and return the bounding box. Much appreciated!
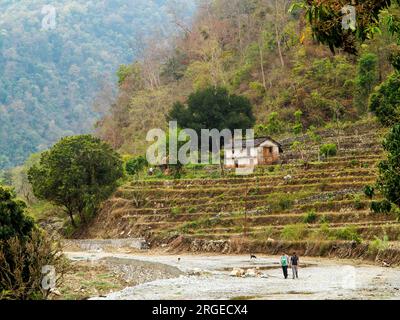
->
[28,135,123,227]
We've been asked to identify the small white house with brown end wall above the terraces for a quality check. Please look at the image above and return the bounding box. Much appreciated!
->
[225,137,283,168]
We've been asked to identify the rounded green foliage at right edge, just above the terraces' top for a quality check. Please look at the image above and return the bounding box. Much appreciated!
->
[369,72,400,126]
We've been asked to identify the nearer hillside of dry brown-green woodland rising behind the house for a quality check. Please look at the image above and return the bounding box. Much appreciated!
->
[98,0,397,154]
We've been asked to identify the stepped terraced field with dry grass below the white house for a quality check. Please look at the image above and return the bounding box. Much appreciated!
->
[86,123,400,261]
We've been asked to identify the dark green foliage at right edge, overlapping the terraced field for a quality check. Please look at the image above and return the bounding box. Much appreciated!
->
[377,124,400,207]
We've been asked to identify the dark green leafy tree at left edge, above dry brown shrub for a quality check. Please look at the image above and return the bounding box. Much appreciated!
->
[0,187,34,240]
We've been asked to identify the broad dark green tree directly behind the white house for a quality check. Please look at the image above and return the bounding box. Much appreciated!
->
[167,87,255,135]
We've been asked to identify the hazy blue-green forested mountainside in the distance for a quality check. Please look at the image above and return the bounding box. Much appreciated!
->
[0,0,194,169]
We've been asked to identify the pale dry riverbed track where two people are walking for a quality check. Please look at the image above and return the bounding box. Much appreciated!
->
[67,252,400,300]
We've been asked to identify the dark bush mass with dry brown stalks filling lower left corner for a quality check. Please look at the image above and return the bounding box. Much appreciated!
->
[0,187,64,300]
